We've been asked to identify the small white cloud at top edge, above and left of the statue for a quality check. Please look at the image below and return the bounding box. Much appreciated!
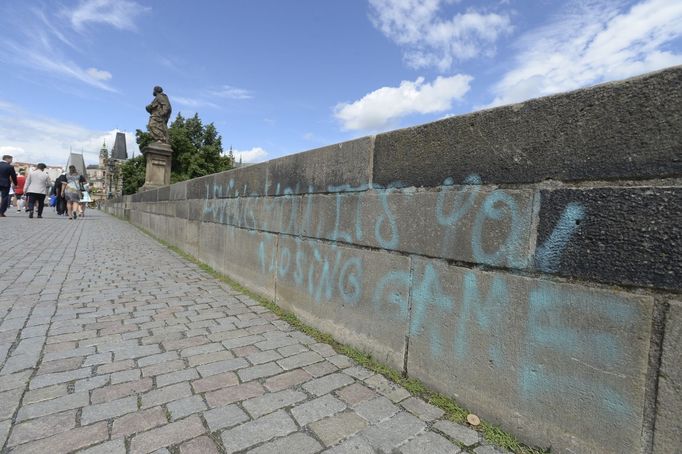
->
[63,0,150,31]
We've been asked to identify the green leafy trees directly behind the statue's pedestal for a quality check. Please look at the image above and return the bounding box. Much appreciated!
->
[123,113,232,194]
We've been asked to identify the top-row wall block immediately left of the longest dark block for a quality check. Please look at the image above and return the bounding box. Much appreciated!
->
[267,137,373,195]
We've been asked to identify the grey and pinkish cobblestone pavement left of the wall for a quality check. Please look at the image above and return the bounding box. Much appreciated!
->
[0,209,504,454]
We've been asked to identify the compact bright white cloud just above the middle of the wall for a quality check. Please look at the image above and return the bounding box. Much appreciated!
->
[334,74,472,130]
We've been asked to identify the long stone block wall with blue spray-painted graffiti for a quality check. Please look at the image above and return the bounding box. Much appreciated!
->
[107,67,682,453]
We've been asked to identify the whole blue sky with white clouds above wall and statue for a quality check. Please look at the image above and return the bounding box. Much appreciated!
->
[0,0,682,164]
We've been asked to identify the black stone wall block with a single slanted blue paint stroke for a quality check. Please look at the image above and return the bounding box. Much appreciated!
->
[535,187,682,290]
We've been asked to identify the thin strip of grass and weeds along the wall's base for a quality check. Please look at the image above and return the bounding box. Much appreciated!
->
[137,227,550,454]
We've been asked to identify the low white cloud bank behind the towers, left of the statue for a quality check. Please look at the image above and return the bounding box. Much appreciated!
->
[0,101,139,165]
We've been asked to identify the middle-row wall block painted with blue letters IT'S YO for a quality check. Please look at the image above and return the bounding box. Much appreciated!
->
[299,188,533,268]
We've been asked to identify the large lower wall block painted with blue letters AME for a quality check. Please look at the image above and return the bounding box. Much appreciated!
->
[407,258,653,453]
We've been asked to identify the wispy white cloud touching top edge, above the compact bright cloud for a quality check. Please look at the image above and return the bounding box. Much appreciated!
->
[369,0,512,71]
